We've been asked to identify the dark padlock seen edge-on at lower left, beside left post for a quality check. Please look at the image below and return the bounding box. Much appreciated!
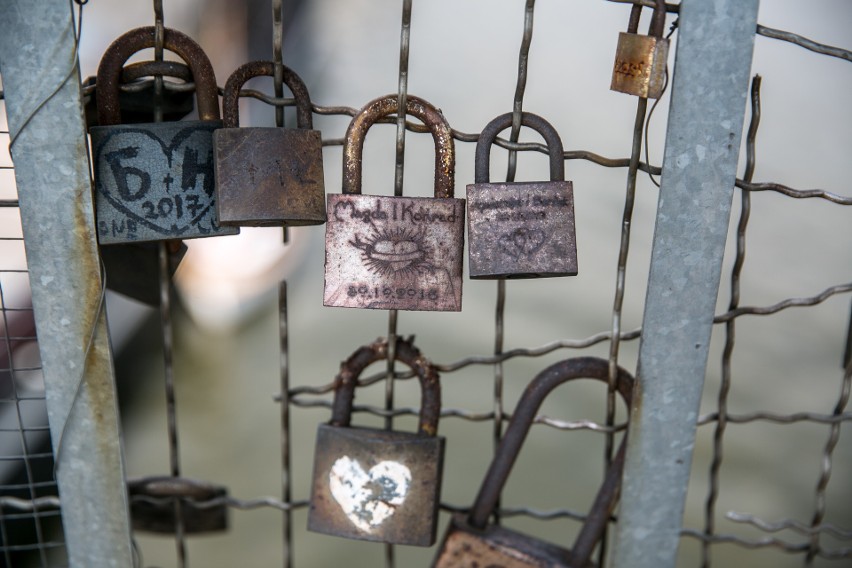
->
[127,476,228,534]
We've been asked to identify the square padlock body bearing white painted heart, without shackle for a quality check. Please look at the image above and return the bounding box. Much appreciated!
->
[308,424,444,546]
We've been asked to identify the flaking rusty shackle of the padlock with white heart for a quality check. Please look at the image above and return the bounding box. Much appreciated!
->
[329,337,441,436]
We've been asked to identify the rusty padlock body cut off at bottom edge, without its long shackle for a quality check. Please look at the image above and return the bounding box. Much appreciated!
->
[434,513,593,568]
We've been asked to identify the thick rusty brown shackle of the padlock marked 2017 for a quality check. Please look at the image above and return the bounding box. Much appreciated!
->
[96,26,219,126]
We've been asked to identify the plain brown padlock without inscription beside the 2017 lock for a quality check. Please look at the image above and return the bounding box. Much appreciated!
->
[213,61,325,226]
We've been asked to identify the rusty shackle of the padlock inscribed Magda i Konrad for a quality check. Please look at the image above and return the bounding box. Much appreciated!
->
[343,94,456,198]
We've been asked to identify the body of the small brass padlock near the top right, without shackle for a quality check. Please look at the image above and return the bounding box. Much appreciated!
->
[609,32,669,99]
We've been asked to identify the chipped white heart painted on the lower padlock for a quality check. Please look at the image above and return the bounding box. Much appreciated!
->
[328,456,411,531]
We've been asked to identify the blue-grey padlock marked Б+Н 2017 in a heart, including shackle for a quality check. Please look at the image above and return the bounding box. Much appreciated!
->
[90,27,239,245]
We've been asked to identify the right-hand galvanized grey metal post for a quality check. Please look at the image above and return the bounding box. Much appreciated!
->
[615,0,758,568]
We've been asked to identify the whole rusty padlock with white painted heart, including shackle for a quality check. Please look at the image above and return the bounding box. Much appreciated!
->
[308,338,444,546]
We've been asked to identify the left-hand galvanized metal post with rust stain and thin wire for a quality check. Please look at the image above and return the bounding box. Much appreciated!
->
[0,0,133,568]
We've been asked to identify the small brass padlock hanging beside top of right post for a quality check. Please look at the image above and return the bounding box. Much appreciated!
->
[609,0,669,99]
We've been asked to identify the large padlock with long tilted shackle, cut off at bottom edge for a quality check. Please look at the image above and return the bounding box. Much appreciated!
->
[433,357,634,568]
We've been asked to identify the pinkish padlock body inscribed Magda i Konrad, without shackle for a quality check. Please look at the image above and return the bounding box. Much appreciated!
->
[323,194,465,311]
